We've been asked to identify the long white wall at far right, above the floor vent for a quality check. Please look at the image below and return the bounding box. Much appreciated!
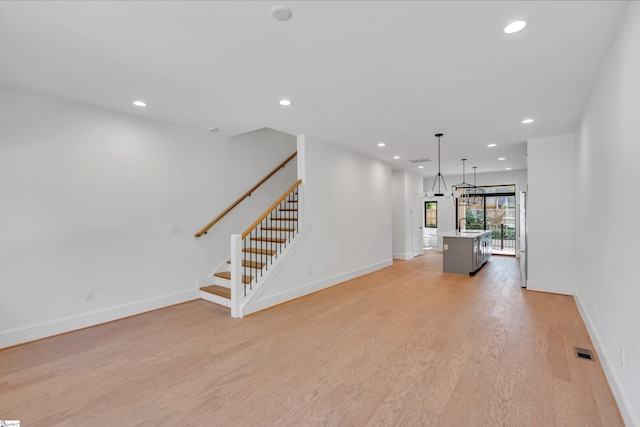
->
[574,2,640,426]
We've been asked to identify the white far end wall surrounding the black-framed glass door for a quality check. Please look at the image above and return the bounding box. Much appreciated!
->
[424,170,527,253]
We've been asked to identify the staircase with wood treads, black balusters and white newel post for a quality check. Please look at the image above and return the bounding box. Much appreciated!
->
[200,181,302,317]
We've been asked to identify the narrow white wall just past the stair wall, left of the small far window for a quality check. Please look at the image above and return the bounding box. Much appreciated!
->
[391,169,424,260]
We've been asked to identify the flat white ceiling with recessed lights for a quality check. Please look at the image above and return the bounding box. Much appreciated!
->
[0,1,626,176]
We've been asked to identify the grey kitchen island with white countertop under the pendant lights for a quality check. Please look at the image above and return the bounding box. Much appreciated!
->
[441,230,492,276]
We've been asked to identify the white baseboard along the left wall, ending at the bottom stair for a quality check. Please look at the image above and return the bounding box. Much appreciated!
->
[0,289,200,349]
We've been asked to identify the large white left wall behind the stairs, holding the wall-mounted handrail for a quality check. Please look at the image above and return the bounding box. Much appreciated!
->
[0,86,296,347]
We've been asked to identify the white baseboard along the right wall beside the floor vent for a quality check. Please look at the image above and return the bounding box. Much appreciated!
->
[574,289,640,427]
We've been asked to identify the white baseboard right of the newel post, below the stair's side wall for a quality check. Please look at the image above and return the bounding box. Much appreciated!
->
[243,258,393,315]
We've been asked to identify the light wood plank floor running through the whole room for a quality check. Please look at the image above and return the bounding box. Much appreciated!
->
[0,252,623,427]
